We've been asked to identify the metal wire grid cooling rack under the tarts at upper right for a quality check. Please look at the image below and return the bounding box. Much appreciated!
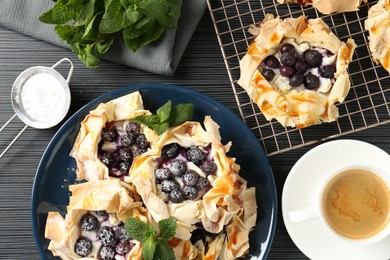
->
[207,0,390,156]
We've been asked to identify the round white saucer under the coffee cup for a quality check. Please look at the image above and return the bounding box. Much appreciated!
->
[282,140,390,260]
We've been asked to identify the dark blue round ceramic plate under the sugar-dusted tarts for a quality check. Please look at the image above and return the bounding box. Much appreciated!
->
[31,84,277,259]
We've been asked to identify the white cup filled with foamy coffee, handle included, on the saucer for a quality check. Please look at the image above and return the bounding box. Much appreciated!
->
[288,165,390,245]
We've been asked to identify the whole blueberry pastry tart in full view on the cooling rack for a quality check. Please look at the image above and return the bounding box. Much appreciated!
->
[238,14,356,128]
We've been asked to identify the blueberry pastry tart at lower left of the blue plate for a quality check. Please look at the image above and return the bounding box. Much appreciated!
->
[45,179,148,260]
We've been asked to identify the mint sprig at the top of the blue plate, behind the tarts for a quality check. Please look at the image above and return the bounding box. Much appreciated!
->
[132,100,193,135]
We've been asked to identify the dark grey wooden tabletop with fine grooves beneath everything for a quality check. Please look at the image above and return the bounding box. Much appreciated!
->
[0,9,390,259]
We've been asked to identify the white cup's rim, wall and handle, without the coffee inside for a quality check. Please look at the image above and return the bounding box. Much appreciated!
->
[288,164,390,245]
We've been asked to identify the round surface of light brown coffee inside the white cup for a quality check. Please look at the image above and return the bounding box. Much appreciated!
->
[322,169,390,239]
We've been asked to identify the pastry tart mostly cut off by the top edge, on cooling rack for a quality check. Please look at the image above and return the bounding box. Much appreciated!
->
[278,0,367,14]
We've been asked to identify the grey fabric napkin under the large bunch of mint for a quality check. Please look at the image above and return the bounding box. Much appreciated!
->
[0,0,206,76]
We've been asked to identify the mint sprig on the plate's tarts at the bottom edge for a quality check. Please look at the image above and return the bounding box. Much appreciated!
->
[125,217,176,260]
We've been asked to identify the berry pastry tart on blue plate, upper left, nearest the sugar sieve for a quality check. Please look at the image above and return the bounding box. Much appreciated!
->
[70,92,156,181]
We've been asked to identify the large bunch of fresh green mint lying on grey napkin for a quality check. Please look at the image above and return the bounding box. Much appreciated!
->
[39,0,180,68]
